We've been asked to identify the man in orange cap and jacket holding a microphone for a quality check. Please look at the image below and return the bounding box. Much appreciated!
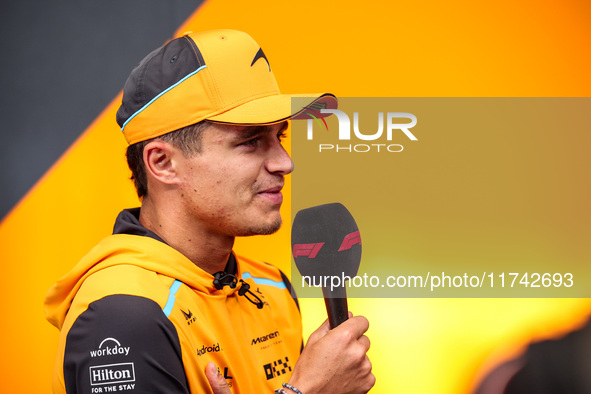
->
[45,30,375,394]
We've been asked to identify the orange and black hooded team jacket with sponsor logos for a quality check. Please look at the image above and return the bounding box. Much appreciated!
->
[45,209,302,394]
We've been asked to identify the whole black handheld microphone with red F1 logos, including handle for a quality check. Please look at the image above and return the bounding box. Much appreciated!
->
[291,203,361,329]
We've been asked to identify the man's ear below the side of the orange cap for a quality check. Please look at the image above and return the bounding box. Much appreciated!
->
[144,140,179,184]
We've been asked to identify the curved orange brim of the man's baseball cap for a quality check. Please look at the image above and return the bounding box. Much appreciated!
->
[207,93,338,124]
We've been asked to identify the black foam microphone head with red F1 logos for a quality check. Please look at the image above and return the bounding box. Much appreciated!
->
[291,203,361,284]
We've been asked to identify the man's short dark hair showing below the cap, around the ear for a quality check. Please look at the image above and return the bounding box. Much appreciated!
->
[126,120,210,198]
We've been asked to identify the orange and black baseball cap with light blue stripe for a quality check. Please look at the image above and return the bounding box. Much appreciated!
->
[117,30,337,145]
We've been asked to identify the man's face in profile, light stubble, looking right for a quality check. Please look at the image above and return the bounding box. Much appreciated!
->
[177,122,292,236]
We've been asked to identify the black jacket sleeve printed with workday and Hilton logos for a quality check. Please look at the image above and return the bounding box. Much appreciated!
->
[63,294,189,393]
